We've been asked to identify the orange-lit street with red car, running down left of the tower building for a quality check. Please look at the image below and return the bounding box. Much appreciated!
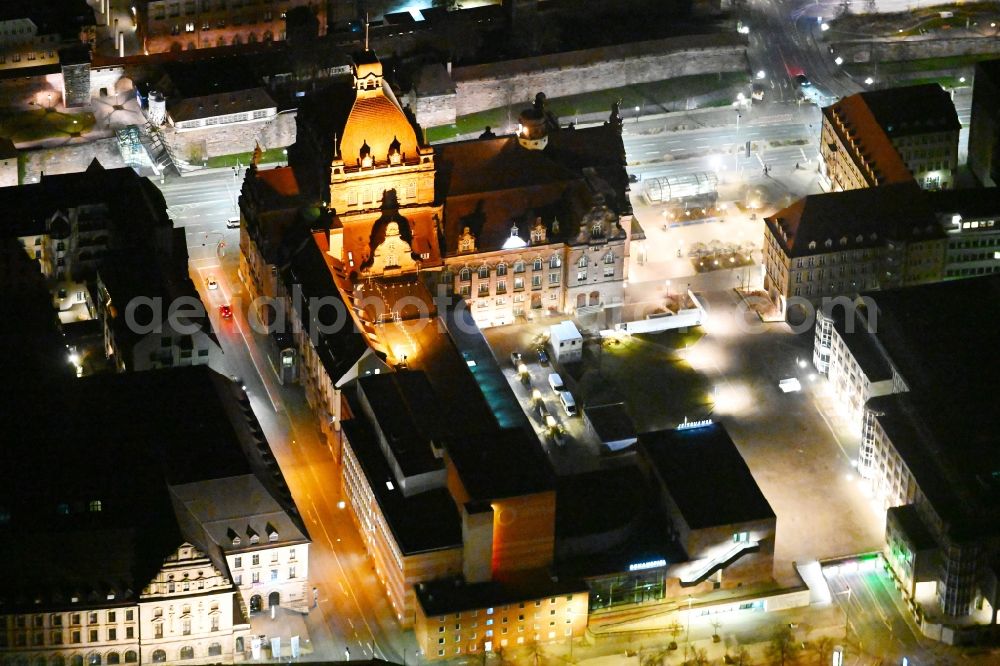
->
[154,166,416,662]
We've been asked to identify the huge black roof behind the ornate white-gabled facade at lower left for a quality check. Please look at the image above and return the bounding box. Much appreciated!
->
[0,366,305,607]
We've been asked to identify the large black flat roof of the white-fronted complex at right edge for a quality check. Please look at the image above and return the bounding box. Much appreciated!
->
[865,275,1000,537]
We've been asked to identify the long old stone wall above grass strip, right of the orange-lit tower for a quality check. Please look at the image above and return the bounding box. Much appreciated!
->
[452,34,747,115]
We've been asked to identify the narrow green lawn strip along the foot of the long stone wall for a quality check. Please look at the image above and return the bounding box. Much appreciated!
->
[427,72,750,143]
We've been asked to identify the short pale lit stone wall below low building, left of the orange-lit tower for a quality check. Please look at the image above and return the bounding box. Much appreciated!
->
[163,110,296,164]
